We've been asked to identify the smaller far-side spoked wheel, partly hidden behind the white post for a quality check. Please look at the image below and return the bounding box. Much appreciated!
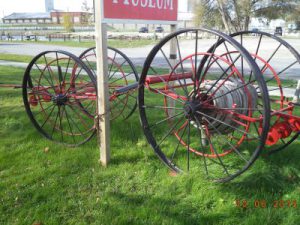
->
[79,47,139,120]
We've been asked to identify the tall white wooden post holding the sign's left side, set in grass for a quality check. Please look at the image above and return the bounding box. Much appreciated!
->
[95,1,110,166]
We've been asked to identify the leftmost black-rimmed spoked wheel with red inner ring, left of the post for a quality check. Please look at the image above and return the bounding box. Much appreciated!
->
[23,51,97,146]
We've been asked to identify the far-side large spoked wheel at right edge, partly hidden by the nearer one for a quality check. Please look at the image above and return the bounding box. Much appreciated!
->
[226,31,300,153]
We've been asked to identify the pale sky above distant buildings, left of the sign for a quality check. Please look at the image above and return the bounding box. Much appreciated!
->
[0,0,93,18]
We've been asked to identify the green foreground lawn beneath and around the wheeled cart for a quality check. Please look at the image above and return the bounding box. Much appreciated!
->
[0,66,300,225]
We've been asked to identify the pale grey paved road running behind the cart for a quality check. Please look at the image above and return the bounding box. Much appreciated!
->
[0,37,300,79]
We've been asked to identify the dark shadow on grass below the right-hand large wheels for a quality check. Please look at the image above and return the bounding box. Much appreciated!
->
[220,143,300,200]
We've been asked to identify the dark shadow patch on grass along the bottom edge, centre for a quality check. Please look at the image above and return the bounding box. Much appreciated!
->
[97,192,228,225]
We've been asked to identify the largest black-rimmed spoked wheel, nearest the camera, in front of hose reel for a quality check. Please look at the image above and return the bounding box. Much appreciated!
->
[138,29,270,182]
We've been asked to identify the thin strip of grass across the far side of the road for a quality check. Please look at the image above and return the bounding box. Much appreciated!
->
[0,39,157,48]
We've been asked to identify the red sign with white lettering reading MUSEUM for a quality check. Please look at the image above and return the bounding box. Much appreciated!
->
[102,0,178,24]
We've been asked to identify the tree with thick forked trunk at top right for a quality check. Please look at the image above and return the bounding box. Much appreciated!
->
[194,0,299,33]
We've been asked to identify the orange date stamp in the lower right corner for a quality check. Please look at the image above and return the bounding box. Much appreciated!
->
[235,199,298,209]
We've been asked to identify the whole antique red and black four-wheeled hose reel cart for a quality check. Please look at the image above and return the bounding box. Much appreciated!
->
[17,29,300,182]
